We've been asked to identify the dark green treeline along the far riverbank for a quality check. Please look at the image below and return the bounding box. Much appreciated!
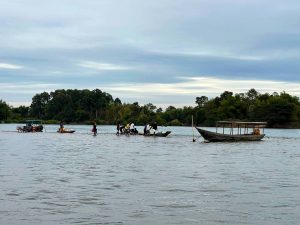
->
[0,89,300,128]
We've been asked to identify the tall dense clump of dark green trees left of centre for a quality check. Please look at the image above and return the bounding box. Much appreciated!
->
[31,89,113,122]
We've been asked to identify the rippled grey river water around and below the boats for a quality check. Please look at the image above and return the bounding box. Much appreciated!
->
[0,125,300,225]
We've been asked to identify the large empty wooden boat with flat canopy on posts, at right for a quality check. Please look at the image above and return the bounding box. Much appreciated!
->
[196,121,267,142]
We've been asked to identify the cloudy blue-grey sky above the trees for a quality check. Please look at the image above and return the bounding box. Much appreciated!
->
[0,0,300,108]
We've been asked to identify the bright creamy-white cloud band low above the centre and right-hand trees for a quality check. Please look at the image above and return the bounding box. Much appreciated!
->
[101,76,300,107]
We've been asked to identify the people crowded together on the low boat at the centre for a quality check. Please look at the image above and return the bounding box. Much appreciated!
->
[116,122,157,135]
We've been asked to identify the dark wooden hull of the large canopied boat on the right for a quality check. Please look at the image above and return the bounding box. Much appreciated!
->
[196,127,265,142]
